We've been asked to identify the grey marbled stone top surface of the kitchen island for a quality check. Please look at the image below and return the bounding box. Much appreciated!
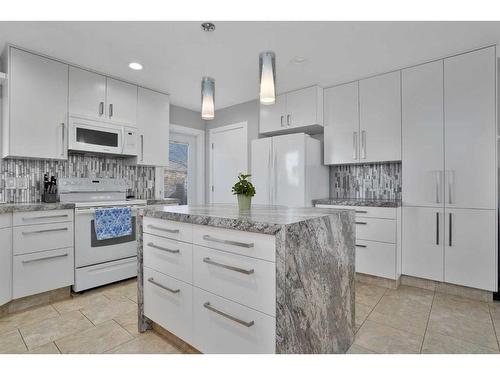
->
[143,204,348,234]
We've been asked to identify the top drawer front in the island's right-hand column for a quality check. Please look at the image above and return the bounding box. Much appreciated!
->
[193,225,276,262]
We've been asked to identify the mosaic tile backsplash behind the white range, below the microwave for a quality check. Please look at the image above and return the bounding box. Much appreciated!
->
[0,154,155,203]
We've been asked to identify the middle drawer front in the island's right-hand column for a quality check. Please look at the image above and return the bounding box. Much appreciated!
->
[193,245,276,316]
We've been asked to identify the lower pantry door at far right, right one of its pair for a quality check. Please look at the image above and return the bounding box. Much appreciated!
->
[444,209,497,291]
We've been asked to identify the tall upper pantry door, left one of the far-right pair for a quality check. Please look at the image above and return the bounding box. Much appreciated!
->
[402,60,444,207]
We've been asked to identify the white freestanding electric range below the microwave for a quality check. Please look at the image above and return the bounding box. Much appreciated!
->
[59,178,146,292]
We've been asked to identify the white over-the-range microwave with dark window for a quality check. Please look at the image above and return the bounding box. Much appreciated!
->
[68,117,124,154]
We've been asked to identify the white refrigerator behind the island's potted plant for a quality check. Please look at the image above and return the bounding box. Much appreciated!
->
[251,133,329,207]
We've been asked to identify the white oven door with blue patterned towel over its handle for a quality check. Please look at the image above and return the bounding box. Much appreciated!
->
[75,207,138,268]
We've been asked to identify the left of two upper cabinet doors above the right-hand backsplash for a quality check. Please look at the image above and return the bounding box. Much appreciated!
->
[324,81,359,164]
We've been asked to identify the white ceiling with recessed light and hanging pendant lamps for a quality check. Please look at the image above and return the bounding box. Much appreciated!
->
[0,22,500,111]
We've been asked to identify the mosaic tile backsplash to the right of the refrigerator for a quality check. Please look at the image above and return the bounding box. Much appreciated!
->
[330,162,401,199]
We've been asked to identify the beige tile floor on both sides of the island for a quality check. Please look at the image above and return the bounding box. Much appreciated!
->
[0,280,500,354]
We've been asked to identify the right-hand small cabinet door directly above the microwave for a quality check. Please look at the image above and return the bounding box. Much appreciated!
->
[106,77,137,125]
